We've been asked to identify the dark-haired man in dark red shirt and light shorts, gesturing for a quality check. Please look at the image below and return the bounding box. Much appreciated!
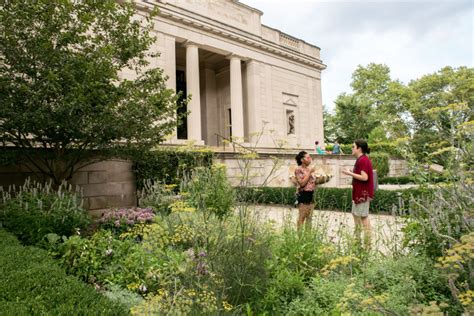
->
[342,139,374,247]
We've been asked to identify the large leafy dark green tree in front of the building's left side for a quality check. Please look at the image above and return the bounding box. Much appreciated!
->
[0,0,183,183]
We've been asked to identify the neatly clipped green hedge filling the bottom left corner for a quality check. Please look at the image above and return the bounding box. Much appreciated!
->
[0,229,129,315]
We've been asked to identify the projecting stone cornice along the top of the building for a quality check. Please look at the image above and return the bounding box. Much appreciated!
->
[136,0,326,70]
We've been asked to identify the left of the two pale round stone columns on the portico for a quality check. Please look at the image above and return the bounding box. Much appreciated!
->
[186,42,202,142]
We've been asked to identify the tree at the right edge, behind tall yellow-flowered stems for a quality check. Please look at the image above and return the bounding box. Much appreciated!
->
[409,67,474,165]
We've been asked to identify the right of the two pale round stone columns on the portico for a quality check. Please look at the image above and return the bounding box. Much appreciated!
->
[230,55,244,141]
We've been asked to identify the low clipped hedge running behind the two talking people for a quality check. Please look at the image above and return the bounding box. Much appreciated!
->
[237,187,431,214]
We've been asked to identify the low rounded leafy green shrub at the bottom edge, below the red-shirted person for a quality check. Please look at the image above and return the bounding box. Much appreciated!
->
[338,254,457,315]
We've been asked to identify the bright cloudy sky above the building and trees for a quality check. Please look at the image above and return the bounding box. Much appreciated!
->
[240,0,474,111]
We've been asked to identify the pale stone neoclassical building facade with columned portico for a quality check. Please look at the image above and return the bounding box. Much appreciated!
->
[132,0,326,150]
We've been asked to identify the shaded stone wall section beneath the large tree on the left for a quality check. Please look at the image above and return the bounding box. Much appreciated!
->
[0,160,137,210]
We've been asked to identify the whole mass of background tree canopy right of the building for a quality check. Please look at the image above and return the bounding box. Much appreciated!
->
[325,64,474,164]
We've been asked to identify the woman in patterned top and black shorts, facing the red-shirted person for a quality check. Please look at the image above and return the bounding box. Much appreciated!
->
[295,151,316,229]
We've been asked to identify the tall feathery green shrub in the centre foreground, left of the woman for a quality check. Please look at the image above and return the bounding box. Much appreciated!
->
[167,210,274,305]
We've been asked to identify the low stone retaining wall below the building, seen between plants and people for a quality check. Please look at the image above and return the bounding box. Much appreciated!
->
[0,153,408,210]
